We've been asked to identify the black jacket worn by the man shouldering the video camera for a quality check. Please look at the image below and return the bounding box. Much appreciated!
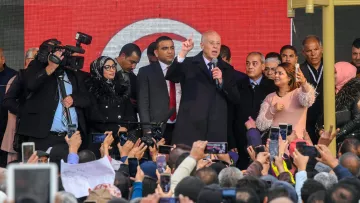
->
[18,60,90,138]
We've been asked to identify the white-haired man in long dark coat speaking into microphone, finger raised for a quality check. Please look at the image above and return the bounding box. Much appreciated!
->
[165,31,239,146]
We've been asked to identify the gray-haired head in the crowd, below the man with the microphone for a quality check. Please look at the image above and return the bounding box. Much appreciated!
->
[219,167,244,188]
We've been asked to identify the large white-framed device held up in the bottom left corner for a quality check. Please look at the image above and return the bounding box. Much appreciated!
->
[6,163,58,203]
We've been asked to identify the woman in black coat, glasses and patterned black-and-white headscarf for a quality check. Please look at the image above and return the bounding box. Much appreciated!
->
[85,56,136,157]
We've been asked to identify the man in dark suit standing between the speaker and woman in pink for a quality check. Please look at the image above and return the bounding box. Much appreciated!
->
[233,52,276,170]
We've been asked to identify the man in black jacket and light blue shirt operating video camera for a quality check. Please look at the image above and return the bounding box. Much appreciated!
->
[17,39,90,151]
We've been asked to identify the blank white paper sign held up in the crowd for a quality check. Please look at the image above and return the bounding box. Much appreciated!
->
[61,156,115,198]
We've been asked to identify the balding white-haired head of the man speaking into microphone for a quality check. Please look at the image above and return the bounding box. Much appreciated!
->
[200,30,221,61]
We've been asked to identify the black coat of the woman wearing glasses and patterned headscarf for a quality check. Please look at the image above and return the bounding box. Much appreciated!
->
[86,77,136,135]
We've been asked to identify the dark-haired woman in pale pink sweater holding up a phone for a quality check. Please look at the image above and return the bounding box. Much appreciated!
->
[256,63,315,137]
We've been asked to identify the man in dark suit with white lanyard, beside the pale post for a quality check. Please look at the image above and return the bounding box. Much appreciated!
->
[300,35,324,143]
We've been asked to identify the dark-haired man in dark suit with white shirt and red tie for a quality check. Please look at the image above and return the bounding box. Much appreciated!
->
[137,36,181,144]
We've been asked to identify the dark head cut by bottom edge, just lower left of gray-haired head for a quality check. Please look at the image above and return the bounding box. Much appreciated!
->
[196,184,222,203]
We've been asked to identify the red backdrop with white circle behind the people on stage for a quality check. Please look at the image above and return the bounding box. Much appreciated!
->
[24,0,291,72]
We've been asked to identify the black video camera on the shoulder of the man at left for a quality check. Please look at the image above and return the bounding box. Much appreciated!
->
[37,32,92,70]
